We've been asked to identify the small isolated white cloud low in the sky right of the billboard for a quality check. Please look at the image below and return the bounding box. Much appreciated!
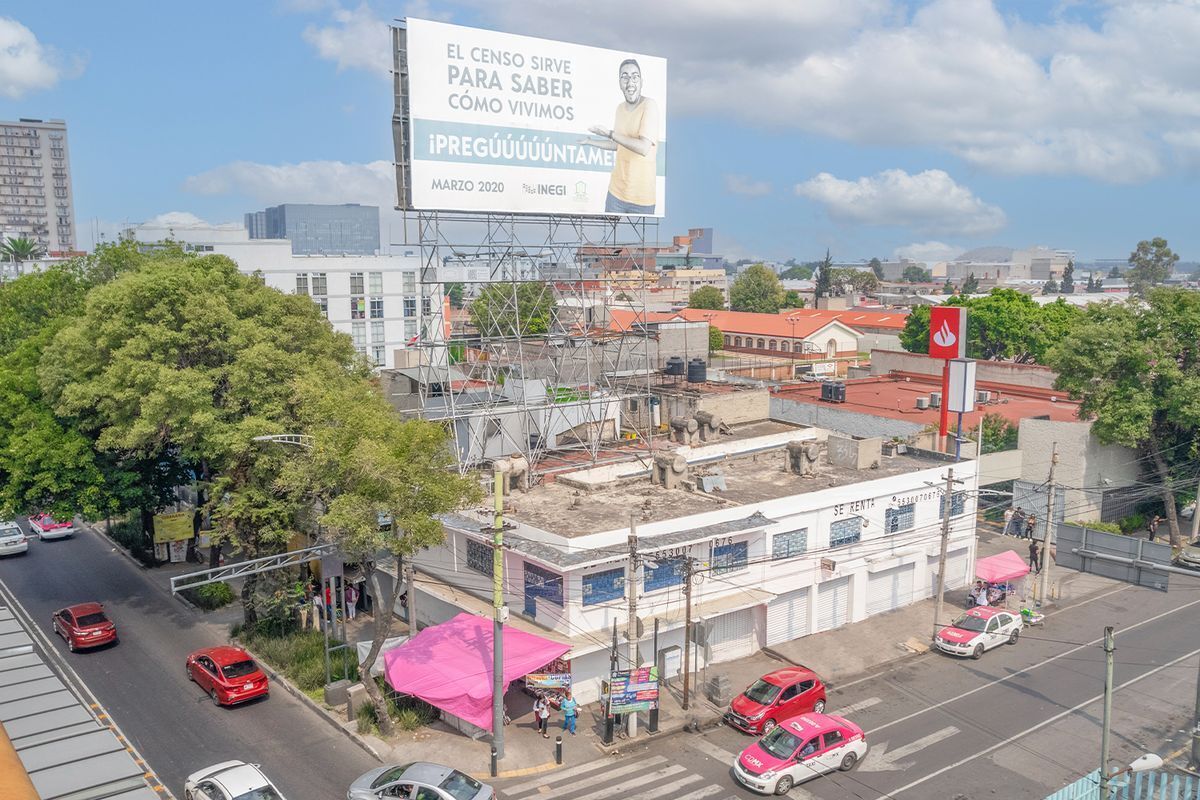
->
[796,169,1006,236]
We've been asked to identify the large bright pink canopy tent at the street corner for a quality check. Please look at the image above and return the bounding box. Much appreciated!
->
[383,613,570,730]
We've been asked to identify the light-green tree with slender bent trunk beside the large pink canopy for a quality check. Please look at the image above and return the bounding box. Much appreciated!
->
[276,369,481,734]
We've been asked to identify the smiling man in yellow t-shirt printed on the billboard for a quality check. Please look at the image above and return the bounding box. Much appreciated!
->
[582,59,659,215]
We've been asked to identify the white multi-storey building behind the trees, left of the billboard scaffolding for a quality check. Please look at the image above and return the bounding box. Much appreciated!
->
[126,224,427,367]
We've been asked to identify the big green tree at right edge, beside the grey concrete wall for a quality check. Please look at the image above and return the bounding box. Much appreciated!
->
[1048,288,1200,547]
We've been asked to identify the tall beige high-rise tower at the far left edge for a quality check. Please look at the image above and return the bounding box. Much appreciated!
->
[0,119,77,253]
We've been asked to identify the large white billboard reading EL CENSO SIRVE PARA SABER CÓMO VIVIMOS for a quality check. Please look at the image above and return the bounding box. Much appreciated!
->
[407,18,667,217]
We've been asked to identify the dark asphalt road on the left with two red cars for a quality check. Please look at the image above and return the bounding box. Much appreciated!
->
[0,523,378,800]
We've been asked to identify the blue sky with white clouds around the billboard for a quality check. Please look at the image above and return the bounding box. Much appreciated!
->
[0,0,1200,260]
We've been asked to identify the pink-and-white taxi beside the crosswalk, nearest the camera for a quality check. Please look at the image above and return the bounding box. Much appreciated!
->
[733,714,866,794]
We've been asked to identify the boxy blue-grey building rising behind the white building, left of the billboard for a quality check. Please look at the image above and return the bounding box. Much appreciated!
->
[246,203,379,255]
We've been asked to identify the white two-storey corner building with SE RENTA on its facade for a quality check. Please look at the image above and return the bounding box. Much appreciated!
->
[416,422,977,703]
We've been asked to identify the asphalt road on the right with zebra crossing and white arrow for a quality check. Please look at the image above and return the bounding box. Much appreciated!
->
[500,576,1200,800]
